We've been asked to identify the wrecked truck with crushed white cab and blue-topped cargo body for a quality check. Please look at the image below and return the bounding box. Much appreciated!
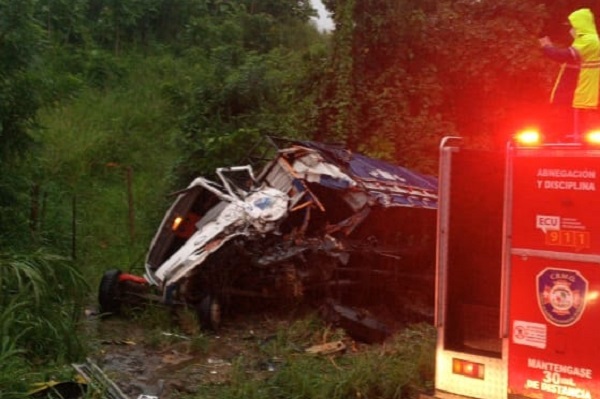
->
[99,141,437,341]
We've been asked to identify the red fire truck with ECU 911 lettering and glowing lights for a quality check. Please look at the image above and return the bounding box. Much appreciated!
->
[423,131,600,399]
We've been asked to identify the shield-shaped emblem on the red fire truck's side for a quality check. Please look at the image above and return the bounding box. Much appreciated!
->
[536,268,588,327]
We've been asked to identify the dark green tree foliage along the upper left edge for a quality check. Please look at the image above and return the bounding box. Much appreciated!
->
[0,0,45,247]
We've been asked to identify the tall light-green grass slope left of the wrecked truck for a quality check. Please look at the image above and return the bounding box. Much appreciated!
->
[31,57,185,285]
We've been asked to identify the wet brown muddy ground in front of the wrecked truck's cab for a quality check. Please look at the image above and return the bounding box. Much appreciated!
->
[86,309,366,399]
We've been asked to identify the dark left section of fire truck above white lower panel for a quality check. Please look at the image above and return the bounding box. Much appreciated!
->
[436,138,507,399]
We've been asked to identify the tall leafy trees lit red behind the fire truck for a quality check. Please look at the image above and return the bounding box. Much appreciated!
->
[320,0,549,172]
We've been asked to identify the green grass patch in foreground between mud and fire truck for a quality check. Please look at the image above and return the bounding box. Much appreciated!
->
[189,317,435,399]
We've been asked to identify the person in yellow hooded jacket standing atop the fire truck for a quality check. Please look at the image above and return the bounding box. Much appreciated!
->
[539,8,600,141]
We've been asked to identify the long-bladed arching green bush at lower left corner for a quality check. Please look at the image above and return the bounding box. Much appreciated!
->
[0,250,86,392]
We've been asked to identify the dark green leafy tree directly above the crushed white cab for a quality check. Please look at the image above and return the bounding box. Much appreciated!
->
[167,0,327,183]
